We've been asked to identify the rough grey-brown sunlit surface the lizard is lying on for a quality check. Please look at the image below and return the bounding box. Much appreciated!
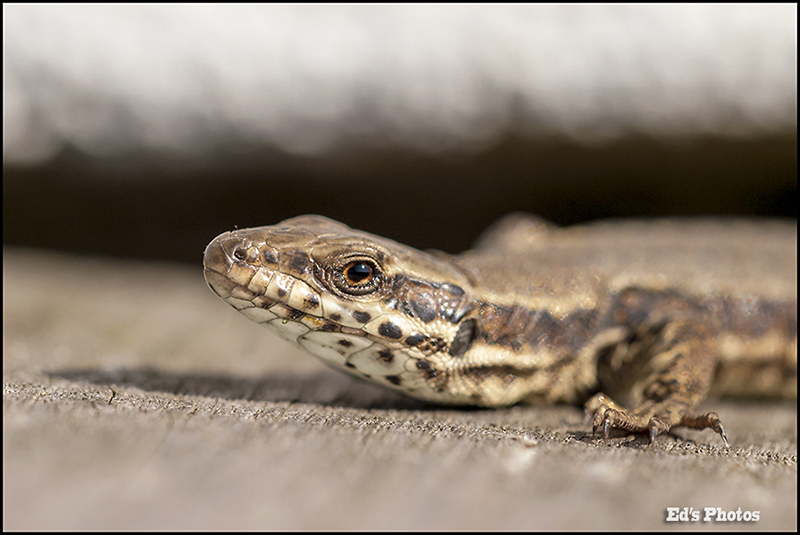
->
[3,248,797,530]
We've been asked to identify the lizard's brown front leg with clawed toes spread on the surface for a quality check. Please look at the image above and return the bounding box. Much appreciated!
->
[586,320,728,447]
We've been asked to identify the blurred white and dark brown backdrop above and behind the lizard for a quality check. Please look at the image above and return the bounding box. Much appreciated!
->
[3,4,797,262]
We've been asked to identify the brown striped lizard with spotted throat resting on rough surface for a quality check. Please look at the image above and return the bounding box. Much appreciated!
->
[203,213,797,447]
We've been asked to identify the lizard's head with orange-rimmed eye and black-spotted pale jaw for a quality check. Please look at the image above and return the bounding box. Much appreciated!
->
[203,216,482,401]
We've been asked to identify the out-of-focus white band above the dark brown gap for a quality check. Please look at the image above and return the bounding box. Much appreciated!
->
[3,4,797,163]
